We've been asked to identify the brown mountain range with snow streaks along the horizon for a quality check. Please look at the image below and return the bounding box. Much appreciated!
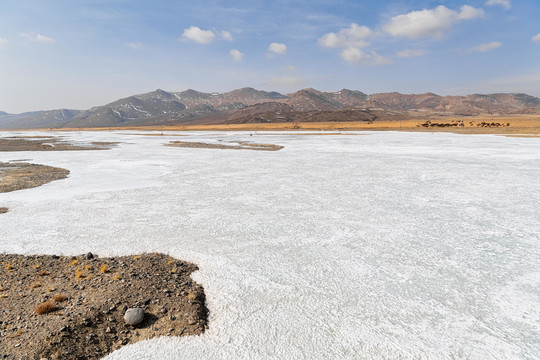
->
[0,88,540,129]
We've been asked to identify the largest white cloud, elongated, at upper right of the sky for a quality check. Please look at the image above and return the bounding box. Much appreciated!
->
[383,5,484,39]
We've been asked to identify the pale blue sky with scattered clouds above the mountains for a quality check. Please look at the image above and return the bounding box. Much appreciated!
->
[0,0,540,113]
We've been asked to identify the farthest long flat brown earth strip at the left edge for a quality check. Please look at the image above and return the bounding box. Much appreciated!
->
[0,136,118,151]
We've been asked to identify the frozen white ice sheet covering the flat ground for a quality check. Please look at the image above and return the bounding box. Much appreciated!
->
[0,132,540,360]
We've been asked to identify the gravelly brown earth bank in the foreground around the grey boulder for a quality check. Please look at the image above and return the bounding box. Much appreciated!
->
[0,253,208,359]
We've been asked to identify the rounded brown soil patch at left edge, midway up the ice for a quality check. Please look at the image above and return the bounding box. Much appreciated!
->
[0,162,69,193]
